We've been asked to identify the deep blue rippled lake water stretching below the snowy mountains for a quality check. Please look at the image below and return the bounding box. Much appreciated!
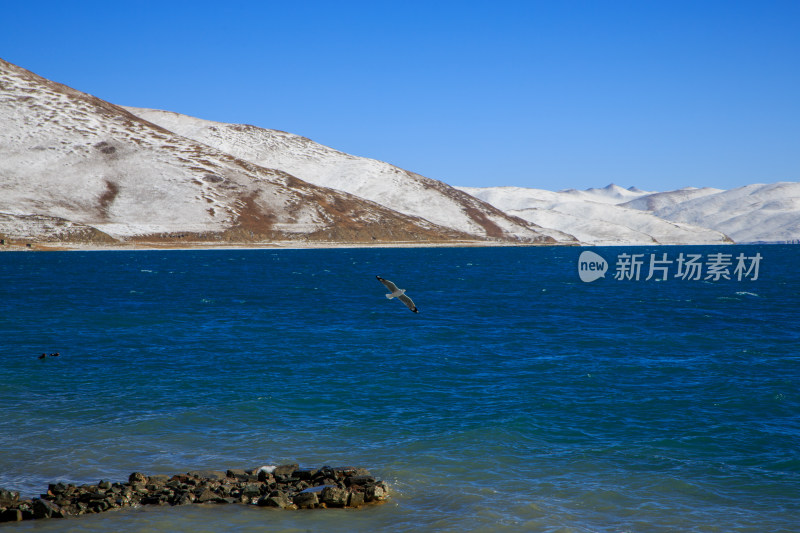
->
[0,245,800,532]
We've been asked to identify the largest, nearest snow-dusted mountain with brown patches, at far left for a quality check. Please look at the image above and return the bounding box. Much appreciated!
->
[0,60,554,242]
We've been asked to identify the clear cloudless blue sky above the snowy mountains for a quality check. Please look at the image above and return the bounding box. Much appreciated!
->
[0,0,800,190]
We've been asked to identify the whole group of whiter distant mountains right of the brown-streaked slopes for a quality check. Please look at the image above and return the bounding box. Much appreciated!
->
[460,182,800,245]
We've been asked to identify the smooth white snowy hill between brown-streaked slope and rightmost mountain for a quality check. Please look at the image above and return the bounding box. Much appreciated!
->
[460,184,731,245]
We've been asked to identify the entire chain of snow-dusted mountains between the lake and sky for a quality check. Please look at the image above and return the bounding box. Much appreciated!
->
[0,59,800,245]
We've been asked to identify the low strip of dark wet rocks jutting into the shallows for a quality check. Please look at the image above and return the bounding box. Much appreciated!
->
[0,465,389,522]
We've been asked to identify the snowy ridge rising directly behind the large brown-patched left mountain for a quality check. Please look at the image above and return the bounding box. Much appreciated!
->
[126,107,574,242]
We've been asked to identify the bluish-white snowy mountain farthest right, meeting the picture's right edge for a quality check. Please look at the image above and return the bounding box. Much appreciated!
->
[622,182,800,242]
